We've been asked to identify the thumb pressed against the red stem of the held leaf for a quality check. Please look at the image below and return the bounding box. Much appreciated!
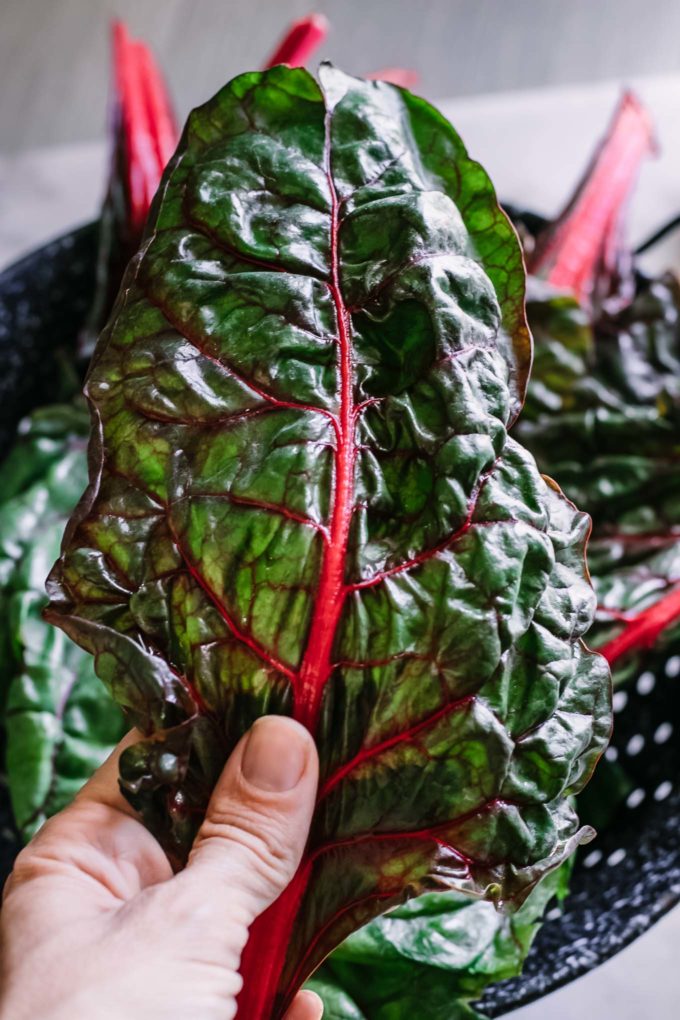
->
[177,716,318,925]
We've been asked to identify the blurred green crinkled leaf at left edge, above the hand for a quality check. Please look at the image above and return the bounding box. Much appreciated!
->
[0,405,123,838]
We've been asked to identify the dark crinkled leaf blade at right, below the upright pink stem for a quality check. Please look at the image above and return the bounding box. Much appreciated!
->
[516,274,680,682]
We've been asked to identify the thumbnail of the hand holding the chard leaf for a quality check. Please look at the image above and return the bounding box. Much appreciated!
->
[241,716,309,794]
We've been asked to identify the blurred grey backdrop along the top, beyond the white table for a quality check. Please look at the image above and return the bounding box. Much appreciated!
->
[0,0,680,153]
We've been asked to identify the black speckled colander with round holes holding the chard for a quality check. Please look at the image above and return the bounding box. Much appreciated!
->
[0,224,680,1017]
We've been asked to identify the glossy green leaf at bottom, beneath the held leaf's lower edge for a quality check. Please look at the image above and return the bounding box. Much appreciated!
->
[310,859,573,1020]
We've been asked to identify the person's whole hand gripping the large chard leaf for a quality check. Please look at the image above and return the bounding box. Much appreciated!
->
[0,716,321,1020]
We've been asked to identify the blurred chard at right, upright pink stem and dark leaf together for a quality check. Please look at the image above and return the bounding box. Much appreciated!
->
[507,89,680,869]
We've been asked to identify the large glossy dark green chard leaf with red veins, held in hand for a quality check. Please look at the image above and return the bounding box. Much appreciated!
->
[49,66,610,1020]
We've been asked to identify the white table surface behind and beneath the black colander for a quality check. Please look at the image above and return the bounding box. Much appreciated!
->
[0,75,680,1020]
